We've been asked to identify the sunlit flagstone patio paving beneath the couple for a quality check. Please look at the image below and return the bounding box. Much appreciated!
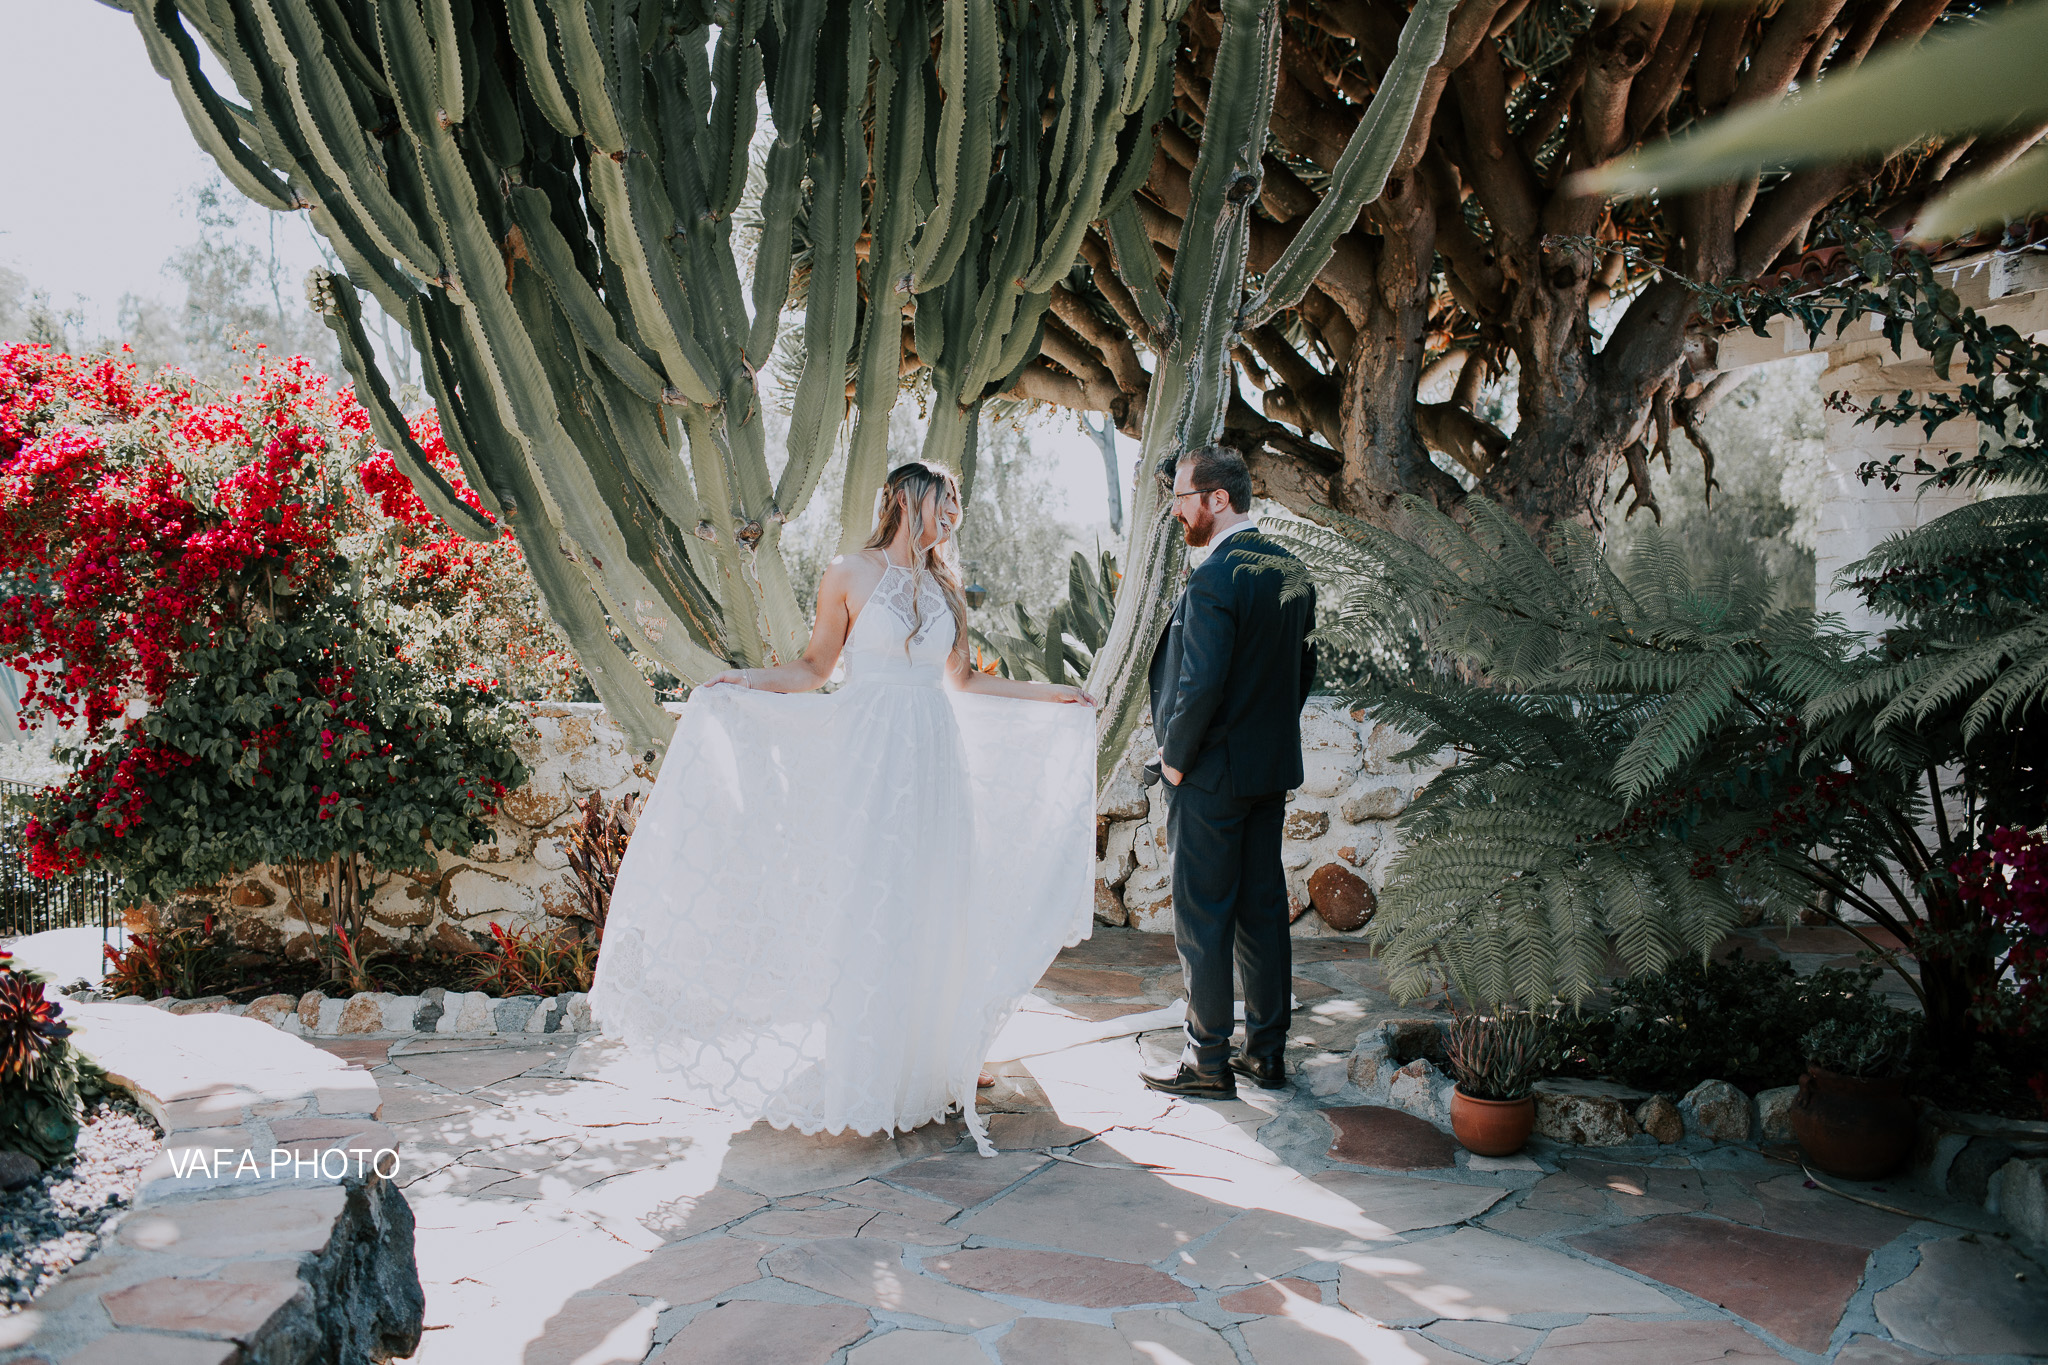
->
[324,931,2048,1365]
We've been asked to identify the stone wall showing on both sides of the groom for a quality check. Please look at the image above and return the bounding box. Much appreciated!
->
[1096,696,1442,937]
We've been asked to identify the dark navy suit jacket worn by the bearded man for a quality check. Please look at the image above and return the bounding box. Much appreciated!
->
[1149,528,1315,796]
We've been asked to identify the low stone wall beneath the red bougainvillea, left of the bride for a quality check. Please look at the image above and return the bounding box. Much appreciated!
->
[148,702,653,954]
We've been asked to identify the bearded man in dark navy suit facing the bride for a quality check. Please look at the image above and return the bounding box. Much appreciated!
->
[1145,446,1315,1099]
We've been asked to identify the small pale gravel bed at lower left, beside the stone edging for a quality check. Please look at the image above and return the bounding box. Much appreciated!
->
[0,1099,162,1316]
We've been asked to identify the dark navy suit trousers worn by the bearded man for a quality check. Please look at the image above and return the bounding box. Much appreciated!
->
[1167,784,1294,1072]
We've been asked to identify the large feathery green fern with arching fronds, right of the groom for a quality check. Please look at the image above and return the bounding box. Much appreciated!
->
[1272,507,2025,1064]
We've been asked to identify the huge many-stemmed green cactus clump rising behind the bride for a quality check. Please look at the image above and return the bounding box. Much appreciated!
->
[127,0,1171,765]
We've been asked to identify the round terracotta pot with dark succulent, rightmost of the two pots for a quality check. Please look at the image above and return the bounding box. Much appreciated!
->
[1788,1001,1919,1181]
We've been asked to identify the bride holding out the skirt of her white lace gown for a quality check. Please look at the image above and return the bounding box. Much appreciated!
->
[590,463,1096,1156]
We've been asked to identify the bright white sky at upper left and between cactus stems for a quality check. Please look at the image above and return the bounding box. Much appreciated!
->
[0,0,1137,524]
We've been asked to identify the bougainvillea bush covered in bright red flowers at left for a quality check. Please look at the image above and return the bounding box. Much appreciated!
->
[0,346,552,962]
